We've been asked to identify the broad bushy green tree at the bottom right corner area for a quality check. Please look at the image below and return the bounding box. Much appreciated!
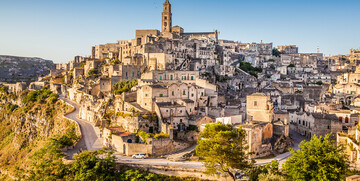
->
[283,134,349,181]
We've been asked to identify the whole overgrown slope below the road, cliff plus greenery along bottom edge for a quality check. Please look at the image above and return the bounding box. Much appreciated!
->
[0,88,202,181]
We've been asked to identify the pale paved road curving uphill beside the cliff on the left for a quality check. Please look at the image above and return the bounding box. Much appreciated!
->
[60,97,102,159]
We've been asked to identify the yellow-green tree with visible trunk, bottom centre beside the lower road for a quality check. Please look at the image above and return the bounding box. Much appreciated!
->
[196,123,252,180]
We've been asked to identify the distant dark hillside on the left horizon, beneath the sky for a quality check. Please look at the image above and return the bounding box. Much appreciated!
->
[0,55,55,82]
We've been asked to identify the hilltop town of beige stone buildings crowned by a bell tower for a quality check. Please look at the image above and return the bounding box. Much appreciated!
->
[2,0,360,180]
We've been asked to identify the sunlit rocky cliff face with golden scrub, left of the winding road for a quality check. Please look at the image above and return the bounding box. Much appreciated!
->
[0,88,78,180]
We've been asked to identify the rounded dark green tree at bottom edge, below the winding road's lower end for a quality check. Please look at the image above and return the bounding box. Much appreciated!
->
[70,150,116,181]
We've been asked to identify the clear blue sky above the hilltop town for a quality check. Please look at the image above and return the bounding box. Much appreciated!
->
[0,0,360,63]
